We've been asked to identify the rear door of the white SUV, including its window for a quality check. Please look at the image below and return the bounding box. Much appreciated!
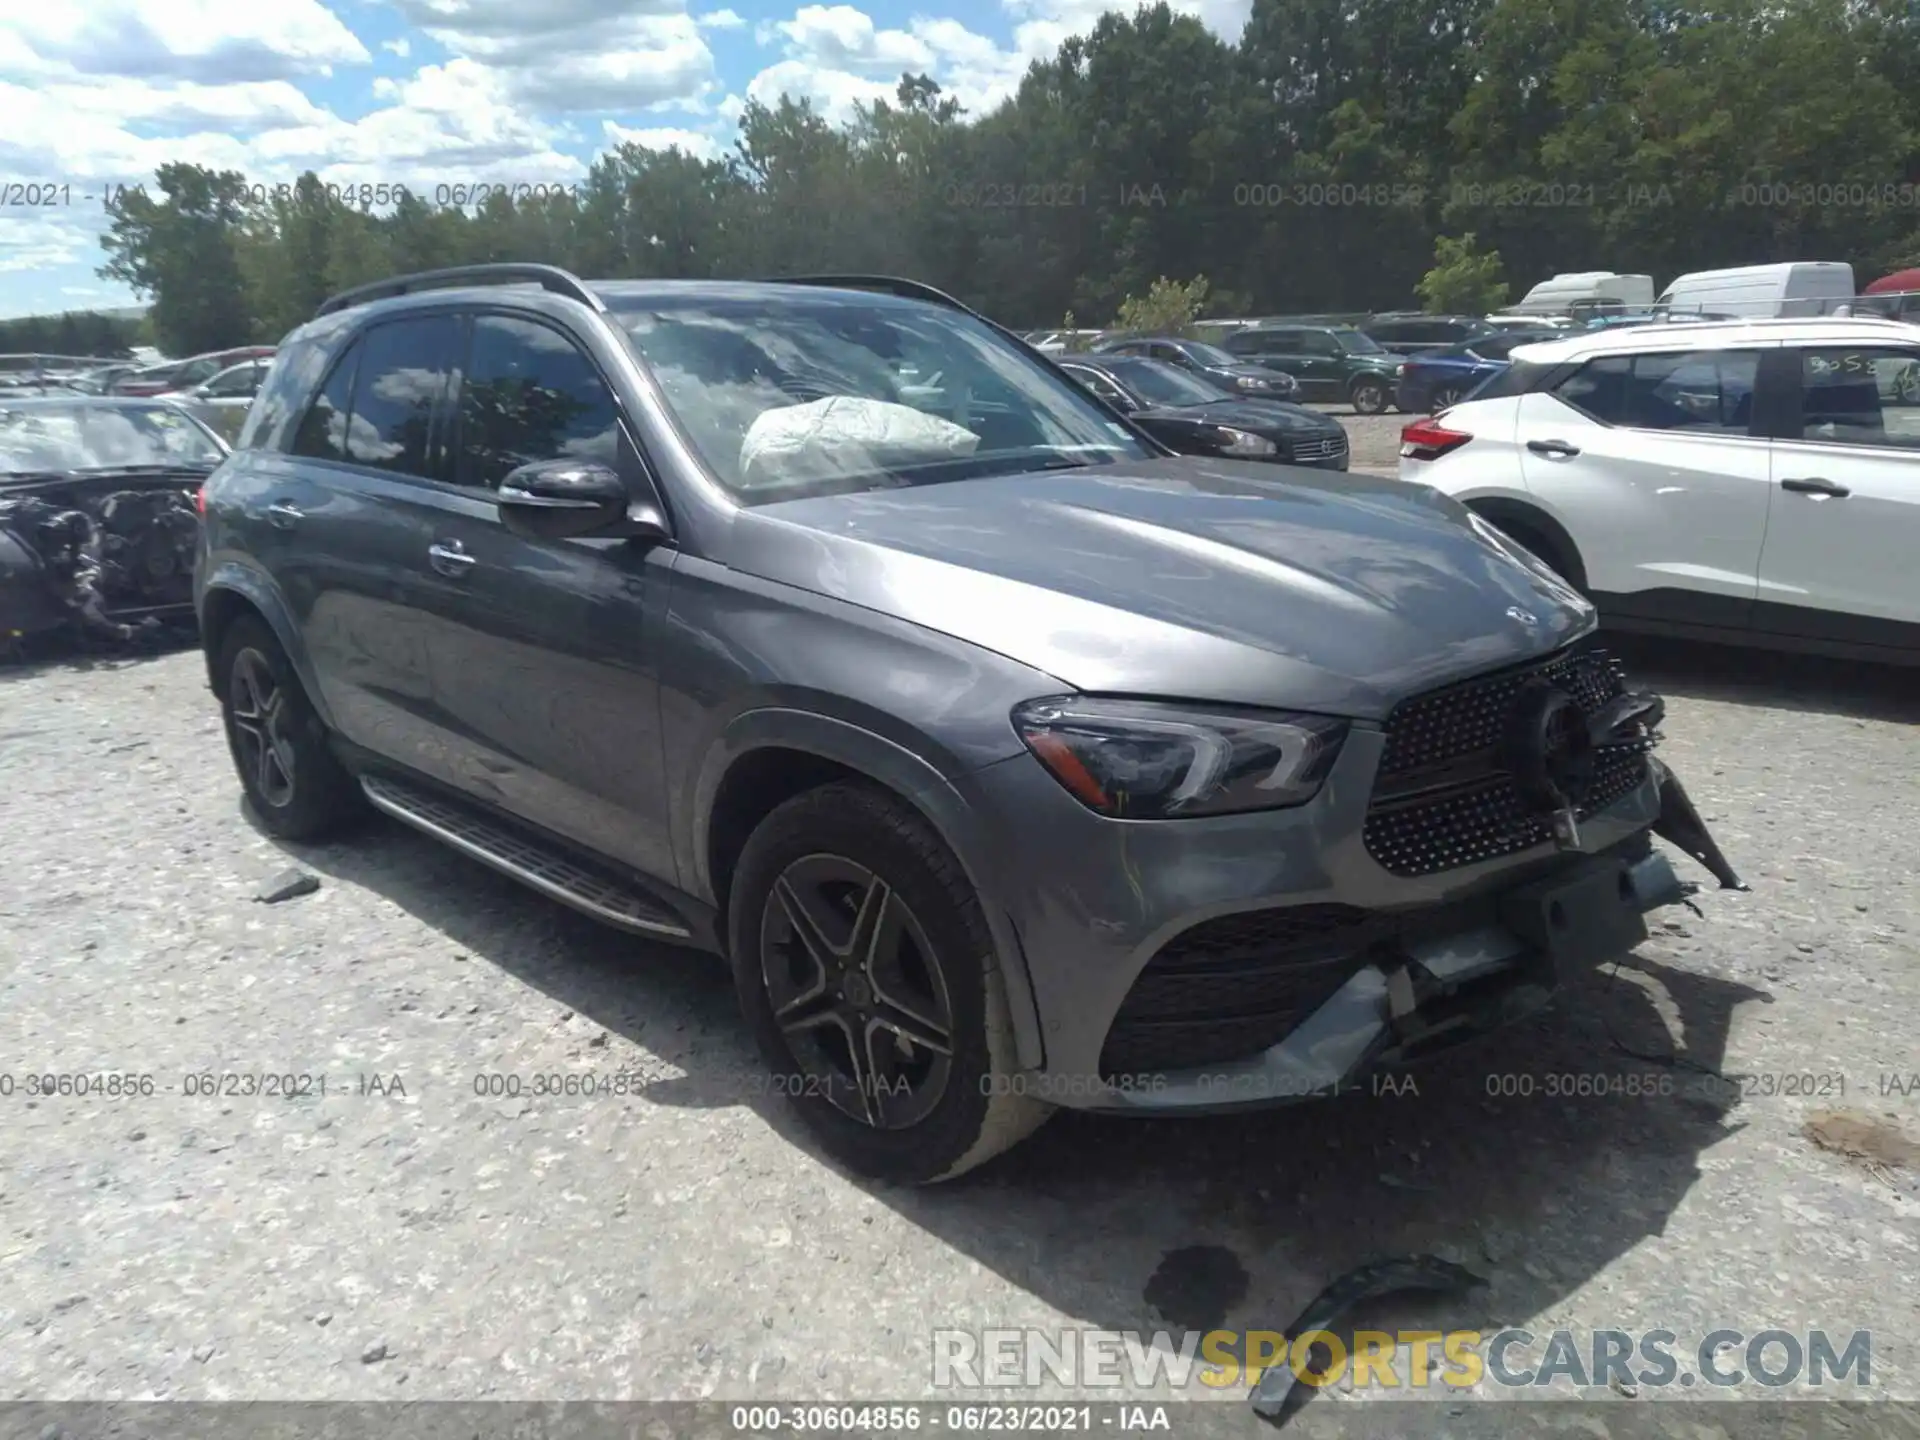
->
[1515,346,1772,628]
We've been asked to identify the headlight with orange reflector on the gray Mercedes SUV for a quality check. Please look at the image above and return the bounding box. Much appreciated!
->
[1014,695,1346,820]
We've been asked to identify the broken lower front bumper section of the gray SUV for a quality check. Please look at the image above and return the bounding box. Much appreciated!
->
[1081,756,1747,1114]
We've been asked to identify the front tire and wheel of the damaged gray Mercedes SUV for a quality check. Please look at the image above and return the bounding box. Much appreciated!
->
[728,783,1052,1185]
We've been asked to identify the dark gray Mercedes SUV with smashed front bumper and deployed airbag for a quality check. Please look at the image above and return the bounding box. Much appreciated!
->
[196,265,1740,1183]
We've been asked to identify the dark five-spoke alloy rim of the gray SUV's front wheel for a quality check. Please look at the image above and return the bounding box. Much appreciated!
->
[760,854,952,1129]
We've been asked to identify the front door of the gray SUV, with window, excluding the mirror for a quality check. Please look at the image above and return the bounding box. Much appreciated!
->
[397,309,678,883]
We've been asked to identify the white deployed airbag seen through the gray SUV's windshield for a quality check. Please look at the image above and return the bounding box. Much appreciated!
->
[739,396,979,488]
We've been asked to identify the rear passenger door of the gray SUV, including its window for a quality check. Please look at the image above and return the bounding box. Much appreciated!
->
[274,313,461,780]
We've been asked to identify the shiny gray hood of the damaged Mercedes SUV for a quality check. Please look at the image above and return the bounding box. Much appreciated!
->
[722,459,1594,720]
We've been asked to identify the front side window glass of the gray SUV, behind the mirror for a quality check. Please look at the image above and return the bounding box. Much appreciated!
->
[459,315,620,490]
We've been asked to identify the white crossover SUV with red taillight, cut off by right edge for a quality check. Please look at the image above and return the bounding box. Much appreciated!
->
[1400,319,1920,664]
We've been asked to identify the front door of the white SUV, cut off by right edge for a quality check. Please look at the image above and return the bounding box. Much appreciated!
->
[1755,342,1920,647]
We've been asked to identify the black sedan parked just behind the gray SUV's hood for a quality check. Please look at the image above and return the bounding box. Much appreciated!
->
[1060,355,1348,470]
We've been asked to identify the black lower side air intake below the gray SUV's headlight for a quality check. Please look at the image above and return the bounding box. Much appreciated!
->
[1100,904,1390,1077]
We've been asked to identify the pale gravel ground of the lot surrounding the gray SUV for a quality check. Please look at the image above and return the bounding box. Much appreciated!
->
[0,641,1920,1434]
